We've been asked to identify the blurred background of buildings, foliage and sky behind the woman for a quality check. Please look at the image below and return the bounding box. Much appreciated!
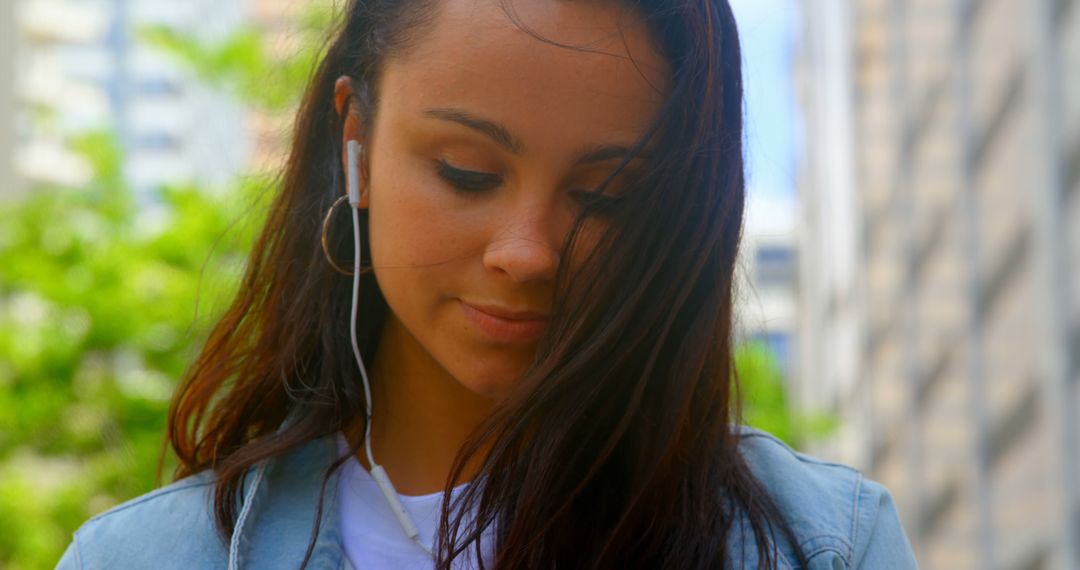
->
[0,0,1080,570]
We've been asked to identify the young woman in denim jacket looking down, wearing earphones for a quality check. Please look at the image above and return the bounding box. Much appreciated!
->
[60,0,915,569]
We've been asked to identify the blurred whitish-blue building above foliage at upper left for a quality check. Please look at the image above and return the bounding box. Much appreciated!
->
[7,0,251,192]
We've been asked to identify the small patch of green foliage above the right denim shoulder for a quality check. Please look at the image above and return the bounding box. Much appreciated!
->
[735,341,837,448]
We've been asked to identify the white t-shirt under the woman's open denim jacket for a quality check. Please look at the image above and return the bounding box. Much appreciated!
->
[338,434,491,570]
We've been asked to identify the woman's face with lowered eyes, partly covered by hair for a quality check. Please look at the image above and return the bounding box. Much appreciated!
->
[337,0,667,396]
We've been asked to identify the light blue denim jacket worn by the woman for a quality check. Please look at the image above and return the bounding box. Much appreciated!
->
[57,428,917,570]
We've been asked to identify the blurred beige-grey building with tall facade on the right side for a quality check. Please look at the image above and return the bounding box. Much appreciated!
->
[796,0,1080,570]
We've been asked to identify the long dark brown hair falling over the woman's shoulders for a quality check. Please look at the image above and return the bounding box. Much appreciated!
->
[167,0,806,569]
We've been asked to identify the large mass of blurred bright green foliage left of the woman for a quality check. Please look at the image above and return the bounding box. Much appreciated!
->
[0,134,268,569]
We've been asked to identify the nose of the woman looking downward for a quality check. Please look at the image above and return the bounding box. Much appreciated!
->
[484,209,559,283]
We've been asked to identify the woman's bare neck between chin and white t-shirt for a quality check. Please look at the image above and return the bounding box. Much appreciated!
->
[349,313,495,496]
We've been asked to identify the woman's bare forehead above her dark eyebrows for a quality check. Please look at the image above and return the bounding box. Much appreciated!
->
[380,0,669,149]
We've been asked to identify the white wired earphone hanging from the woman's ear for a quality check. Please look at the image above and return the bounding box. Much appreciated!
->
[346,139,434,556]
